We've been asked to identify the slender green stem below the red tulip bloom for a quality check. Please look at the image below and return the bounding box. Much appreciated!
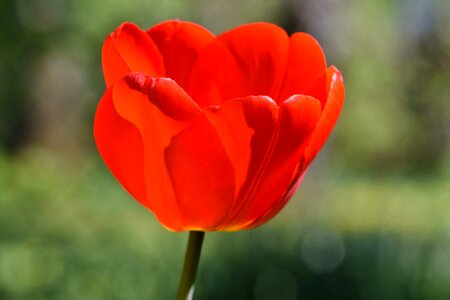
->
[177,231,205,300]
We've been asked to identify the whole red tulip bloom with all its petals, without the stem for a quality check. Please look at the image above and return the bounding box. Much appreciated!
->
[94,21,344,231]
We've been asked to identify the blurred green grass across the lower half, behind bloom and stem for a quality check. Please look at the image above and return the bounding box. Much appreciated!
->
[0,150,450,299]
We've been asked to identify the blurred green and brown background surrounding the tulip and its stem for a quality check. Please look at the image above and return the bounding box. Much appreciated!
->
[0,0,450,300]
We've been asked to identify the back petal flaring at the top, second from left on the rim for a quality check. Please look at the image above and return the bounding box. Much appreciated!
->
[147,20,214,89]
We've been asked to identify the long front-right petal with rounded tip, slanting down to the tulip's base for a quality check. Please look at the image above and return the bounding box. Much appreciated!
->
[221,95,320,230]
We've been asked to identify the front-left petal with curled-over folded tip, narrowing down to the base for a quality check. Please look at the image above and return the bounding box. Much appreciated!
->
[103,73,201,231]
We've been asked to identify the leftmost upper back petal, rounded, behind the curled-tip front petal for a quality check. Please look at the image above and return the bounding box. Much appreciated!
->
[102,23,165,87]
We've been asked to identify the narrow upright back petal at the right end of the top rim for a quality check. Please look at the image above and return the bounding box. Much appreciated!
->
[278,32,327,107]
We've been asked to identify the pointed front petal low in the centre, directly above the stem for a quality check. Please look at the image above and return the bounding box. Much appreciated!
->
[165,115,235,231]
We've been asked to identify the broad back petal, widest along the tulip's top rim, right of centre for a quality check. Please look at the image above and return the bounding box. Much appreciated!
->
[188,23,289,107]
